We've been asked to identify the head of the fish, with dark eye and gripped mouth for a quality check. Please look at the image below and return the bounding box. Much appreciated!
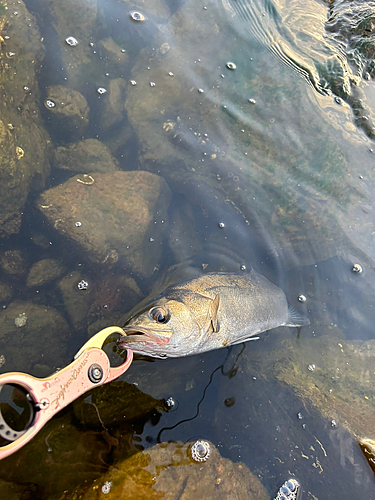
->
[118,298,200,358]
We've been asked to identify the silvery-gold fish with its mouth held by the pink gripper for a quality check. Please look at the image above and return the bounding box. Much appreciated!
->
[118,269,310,358]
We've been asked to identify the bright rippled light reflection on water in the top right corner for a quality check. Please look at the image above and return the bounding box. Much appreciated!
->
[223,0,374,139]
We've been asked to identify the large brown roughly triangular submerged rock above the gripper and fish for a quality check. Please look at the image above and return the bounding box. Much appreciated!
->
[38,171,171,277]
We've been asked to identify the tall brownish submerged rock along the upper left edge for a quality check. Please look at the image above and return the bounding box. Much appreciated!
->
[0,0,50,236]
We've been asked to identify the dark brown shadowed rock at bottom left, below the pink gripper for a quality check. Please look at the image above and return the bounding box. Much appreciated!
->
[0,411,131,500]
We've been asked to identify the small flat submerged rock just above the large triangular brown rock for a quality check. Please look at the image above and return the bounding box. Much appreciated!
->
[54,139,119,174]
